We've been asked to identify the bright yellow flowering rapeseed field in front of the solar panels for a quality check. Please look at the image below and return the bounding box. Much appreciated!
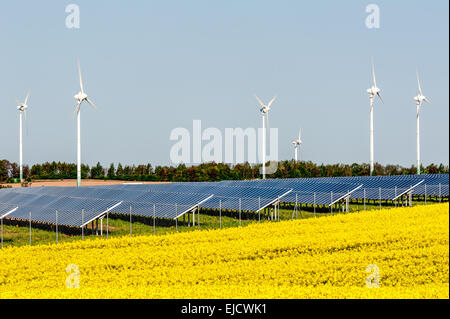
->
[0,203,449,298]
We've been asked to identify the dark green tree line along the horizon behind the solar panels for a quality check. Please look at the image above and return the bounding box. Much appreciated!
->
[0,160,449,182]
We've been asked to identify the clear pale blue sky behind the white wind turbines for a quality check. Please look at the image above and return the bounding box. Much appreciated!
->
[0,0,449,166]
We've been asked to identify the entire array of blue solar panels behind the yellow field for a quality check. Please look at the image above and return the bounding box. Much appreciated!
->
[0,174,448,230]
